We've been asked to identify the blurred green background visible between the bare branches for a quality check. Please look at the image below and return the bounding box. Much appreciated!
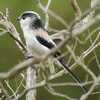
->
[0,0,100,100]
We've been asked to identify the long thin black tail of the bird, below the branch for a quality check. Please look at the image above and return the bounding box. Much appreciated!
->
[58,58,87,93]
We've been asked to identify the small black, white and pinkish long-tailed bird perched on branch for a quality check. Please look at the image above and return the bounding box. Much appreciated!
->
[18,11,86,93]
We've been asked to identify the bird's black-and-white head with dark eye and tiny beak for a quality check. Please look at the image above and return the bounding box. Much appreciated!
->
[18,11,42,29]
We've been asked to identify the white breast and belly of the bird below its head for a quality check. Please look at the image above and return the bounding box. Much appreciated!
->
[24,30,50,58]
